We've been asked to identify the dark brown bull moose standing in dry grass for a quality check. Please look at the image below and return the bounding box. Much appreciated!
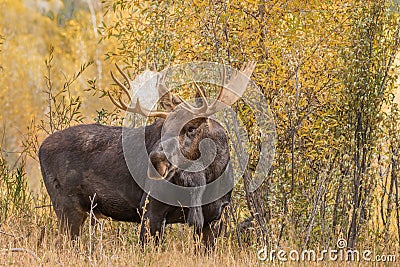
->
[39,62,255,246]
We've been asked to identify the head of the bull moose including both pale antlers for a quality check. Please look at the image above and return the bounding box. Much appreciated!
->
[108,61,255,182]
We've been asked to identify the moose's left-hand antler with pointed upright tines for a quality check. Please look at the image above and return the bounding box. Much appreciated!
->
[108,64,169,119]
